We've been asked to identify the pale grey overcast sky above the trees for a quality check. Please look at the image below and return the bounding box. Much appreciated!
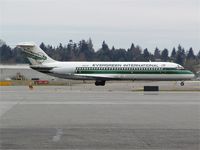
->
[0,0,200,52]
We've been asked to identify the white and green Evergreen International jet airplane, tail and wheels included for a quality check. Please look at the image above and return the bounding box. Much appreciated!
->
[17,42,194,86]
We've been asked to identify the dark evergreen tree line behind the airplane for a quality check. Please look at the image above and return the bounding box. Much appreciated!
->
[0,39,200,71]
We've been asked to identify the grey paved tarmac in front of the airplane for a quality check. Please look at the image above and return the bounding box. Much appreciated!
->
[0,82,200,150]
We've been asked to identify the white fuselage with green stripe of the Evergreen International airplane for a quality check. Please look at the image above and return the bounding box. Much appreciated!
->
[31,61,194,81]
